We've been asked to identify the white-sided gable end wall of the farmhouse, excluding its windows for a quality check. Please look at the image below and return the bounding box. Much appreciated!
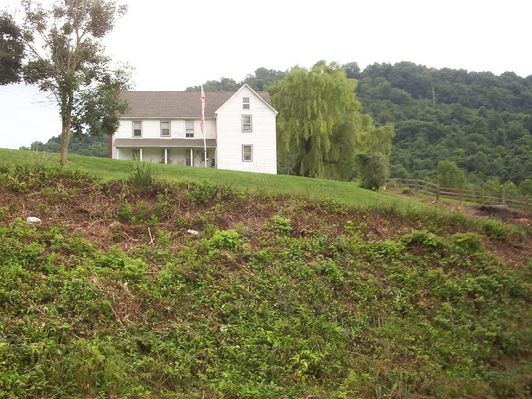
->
[216,87,277,174]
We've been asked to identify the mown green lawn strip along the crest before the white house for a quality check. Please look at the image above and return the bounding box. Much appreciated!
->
[0,149,428,209]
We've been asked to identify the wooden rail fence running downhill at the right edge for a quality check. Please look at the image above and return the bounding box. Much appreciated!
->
[386,179,532,213]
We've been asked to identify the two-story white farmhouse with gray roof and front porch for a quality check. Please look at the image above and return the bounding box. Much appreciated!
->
[110,84,277,173]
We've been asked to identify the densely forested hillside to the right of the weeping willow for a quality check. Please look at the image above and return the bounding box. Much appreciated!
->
[352,62,532,183]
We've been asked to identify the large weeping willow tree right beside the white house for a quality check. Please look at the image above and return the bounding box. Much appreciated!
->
[269,61,367,179]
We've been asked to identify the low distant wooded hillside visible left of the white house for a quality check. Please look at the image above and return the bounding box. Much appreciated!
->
[20,136,109,157]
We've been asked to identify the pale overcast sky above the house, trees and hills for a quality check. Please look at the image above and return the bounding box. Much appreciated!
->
[0,0,532,148]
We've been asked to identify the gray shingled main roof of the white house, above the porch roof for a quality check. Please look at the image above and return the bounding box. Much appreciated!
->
[122,91,270,118]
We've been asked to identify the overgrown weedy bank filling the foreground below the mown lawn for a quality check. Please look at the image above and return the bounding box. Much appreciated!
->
[0,152,532,399]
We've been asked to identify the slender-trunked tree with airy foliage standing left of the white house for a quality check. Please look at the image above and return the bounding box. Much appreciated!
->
[0,0,129,166]
